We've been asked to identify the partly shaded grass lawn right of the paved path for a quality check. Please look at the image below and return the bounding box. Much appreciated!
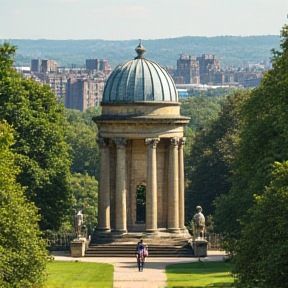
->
[166,261,234,288]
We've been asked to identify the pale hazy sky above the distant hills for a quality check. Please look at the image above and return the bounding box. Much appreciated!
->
[0,0,288,40]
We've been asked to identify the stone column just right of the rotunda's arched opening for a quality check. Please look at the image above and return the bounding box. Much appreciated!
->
[145,138,160,232]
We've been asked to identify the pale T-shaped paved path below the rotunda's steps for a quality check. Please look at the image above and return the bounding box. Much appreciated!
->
[55,251,225,288]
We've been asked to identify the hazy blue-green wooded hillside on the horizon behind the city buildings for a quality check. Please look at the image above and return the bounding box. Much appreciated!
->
[0,35,280,68]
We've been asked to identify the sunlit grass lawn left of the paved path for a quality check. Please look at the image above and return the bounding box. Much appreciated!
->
[44,261,114,288]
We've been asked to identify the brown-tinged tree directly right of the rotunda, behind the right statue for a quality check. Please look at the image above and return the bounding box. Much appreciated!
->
[186,90,249,220]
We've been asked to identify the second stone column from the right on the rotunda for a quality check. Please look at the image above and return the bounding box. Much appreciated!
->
[168,138,179,232]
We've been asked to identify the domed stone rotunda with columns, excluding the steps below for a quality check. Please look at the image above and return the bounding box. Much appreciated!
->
[93,43,190,233]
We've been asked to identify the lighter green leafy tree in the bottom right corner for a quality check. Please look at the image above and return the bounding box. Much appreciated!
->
[233,161,288,288]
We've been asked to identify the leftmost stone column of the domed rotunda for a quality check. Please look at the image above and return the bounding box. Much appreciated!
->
[97,138,111,232]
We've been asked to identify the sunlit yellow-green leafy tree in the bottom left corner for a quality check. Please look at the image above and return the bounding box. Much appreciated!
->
[0,122,47,288]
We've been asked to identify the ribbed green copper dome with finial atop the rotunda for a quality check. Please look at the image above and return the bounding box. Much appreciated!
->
[102,43,178,103]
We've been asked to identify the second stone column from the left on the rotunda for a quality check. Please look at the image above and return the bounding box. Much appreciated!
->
[113,138,127,233]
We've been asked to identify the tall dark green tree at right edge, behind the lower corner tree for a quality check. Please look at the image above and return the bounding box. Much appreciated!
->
[214,25,288,252]
